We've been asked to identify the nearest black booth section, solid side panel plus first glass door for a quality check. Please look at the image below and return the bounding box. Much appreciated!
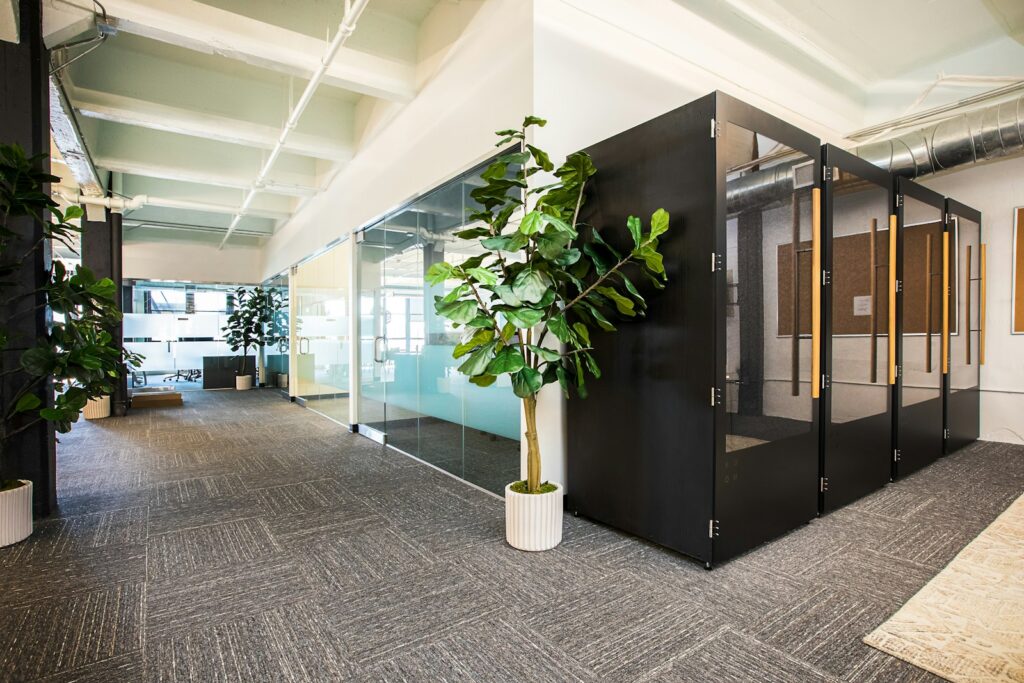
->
[567,93,820,566]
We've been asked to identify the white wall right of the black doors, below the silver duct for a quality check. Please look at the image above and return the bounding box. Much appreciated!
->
[922,158,1024,443]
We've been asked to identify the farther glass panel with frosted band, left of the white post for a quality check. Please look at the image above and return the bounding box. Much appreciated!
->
[292,241,351,424]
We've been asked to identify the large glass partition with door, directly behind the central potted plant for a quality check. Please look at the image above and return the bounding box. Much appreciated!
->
[356,157,520,494]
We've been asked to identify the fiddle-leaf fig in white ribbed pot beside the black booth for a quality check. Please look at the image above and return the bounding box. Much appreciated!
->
[427,117,669,550]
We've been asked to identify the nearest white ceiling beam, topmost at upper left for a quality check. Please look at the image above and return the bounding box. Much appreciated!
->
[96,0,416,101]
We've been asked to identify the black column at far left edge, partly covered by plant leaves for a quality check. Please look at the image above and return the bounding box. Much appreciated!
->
[0,0,56,515]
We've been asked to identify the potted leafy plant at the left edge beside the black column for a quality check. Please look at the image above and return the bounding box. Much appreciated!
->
[0,144,141,547]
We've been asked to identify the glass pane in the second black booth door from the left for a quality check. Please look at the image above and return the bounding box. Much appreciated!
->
[831,170,889,423]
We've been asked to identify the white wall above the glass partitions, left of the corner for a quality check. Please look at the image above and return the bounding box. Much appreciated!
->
[263,0,532,275]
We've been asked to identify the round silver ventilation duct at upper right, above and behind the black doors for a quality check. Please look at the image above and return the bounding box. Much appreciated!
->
[726,95,1024,214]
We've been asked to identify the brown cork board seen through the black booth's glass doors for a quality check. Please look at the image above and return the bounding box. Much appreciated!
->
[777,219,950,337]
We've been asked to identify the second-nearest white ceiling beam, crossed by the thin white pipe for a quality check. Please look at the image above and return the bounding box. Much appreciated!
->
[69,88,353,162]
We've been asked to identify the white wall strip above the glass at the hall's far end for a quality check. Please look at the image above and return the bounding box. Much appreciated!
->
[121,241,263,285]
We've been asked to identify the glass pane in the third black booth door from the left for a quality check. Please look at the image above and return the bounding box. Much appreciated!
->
[901,196,944,405]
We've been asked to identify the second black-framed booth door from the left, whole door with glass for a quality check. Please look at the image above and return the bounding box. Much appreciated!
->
[819,145,893,511]
